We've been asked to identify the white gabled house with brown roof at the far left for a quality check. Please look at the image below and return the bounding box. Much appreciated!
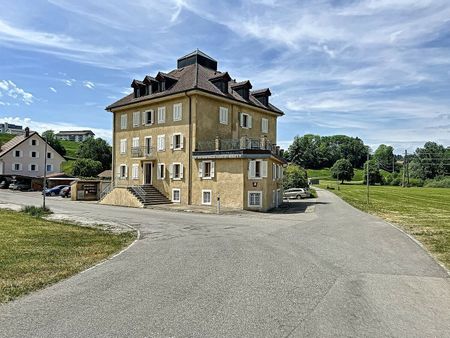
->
[0,128,65,178]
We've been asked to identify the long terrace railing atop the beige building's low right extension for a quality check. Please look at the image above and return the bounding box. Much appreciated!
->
[196,137,283,155]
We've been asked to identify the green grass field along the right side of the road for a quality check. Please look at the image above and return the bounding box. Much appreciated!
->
[320,182,450,269]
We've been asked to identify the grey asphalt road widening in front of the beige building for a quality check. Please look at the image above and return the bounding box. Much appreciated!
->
[0,191,450,337]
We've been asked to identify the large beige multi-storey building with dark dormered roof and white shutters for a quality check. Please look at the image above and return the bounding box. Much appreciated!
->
[102,50,285,211]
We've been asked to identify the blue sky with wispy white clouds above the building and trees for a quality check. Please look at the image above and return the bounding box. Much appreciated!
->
[0,0,450,152]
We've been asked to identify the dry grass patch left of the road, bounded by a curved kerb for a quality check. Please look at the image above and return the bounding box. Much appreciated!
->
[0,209,135,303]
